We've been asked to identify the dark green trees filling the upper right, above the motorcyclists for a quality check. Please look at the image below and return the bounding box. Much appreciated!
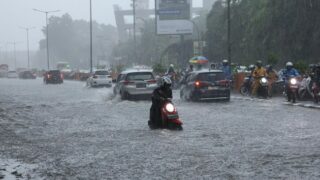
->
[206,0,320,64]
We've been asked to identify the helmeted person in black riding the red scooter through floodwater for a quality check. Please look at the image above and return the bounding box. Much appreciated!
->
[148,76,172,129]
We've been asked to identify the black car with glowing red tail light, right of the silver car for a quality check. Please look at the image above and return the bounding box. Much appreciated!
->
[180,70,230,101]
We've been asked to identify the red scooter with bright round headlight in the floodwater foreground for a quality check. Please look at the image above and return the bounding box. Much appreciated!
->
[148,99,183,130]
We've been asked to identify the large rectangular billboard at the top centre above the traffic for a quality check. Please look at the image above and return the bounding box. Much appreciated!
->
[155,0,193,35]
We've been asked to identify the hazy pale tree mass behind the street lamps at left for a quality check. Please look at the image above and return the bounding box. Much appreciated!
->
[39,14,117,69]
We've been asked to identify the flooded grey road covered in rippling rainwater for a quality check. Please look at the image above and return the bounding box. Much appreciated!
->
[0,79,320,179]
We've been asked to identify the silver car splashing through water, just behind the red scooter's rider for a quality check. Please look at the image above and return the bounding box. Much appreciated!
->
[113,70,158,100]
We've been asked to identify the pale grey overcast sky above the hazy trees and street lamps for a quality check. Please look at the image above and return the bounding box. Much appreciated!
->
[0,0,201,51]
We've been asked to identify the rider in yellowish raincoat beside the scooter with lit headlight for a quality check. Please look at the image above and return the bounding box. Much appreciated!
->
[252,60,268,96]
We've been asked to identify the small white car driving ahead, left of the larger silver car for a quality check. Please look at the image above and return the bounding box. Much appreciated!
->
[87,70,112,87]
